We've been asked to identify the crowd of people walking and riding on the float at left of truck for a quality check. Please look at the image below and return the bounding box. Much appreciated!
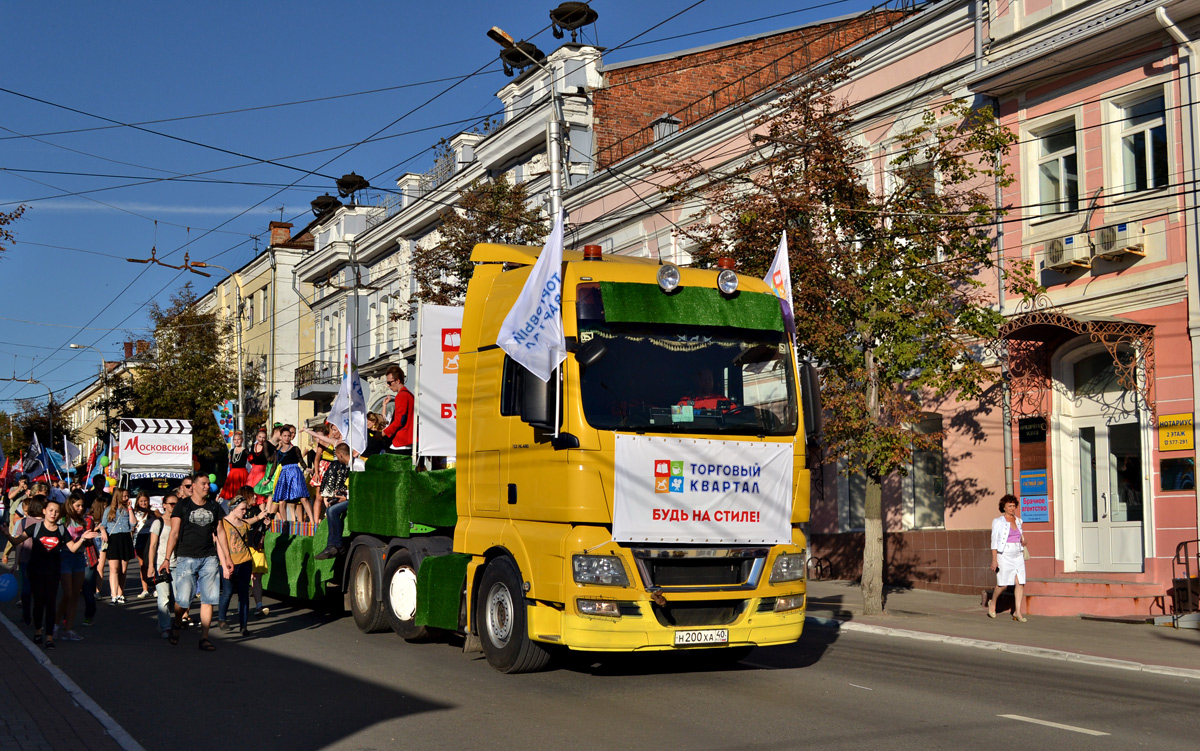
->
[0,366,414,651]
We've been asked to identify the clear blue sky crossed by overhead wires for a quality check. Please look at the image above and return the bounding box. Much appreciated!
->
[0,0,870,410]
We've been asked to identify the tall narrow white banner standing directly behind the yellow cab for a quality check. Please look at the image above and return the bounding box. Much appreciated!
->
[416,305,462,456]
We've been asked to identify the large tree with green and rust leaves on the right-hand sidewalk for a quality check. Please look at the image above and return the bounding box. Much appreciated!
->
[672,60,1028,613]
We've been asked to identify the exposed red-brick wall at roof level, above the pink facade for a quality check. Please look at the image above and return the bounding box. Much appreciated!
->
[594,11,906,167]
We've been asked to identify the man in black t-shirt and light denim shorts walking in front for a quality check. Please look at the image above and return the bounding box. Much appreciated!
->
[158,473,233,651]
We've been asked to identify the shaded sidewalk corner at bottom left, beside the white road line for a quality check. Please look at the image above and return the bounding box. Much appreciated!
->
[0,566,133,751]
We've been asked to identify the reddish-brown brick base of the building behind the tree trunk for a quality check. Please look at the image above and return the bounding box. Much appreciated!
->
[809,529,996,595]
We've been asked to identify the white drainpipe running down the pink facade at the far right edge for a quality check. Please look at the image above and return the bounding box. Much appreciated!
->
[1154,7,1200,534]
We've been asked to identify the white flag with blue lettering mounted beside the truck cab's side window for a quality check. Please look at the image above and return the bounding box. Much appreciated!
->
[497,212,566,381]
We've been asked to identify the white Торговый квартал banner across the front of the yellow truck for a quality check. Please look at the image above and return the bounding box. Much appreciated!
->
[612,433,792,545]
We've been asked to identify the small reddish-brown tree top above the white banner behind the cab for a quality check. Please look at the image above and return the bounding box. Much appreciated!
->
[408,175,548,314]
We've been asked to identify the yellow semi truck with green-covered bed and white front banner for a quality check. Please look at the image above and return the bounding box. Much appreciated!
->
[268,245,812,672]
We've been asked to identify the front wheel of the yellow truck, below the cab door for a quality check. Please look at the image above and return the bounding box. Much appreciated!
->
[475,557,550,673]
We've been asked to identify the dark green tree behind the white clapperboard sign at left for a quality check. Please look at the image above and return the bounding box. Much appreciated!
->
[101,283,263,459]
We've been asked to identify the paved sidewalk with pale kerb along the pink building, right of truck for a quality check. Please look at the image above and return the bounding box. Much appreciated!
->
[808,581,1200,679]
